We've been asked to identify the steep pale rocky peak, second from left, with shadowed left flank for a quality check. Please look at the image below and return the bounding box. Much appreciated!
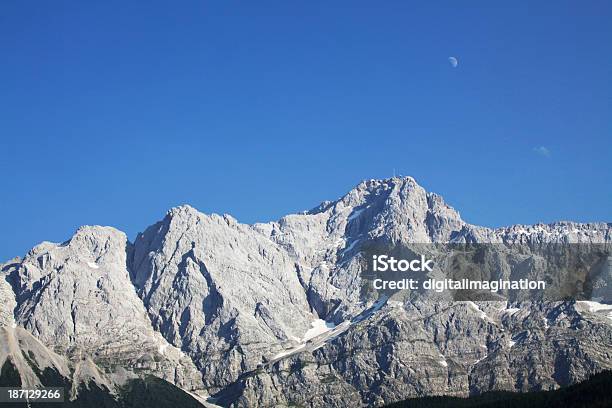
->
[132,206,315,389]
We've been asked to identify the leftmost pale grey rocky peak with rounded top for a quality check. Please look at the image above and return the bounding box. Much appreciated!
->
[2,227,202,396]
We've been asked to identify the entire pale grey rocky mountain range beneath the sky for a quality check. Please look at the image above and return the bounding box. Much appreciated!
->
[0,177,612,407]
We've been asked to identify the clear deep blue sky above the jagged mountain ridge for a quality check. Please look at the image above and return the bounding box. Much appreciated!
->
[0,0,612,259]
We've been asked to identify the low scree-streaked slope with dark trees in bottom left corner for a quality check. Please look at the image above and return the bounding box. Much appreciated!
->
[0,327,202,408]
